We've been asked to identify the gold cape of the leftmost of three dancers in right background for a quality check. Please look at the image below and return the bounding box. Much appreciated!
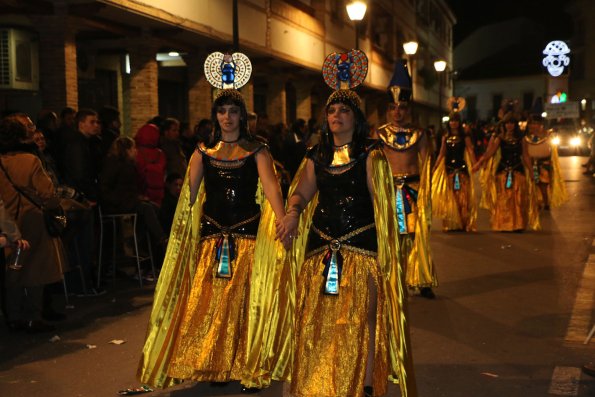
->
[432,150,477,230]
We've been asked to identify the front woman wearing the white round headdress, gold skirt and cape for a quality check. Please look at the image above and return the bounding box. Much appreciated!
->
[138,52,291,393]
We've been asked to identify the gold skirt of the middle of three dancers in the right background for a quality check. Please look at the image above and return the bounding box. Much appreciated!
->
[491,171,529,232]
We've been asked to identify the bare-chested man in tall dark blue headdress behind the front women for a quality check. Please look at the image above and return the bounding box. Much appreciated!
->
[377,60,438,299]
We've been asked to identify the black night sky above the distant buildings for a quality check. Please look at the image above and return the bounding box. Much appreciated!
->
[446,0,572,46]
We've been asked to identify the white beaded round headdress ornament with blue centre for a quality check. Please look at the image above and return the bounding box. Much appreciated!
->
[205,52,252,89]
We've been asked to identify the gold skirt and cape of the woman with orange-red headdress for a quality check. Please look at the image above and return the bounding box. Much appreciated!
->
[290,149,417,397]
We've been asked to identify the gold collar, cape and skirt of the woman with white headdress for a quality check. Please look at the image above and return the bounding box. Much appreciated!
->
[138,141,294,387]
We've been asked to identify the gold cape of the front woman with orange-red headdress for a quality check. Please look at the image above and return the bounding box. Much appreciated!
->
[288,149,417,397]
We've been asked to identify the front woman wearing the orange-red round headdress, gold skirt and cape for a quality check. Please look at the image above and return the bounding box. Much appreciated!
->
[281,50,417,397]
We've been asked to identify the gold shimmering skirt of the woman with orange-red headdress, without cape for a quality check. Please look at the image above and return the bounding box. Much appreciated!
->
[291,248,389,397]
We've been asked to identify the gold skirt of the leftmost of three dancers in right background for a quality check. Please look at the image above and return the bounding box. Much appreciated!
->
[442,172,477,232]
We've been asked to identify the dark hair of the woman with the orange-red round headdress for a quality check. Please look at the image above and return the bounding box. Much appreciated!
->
[316,94,369,166]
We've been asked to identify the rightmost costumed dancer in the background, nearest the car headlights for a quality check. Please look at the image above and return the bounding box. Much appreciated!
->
[525,98,568,210]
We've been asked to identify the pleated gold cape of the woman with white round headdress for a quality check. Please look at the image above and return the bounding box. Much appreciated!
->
[137,171,294,388]
